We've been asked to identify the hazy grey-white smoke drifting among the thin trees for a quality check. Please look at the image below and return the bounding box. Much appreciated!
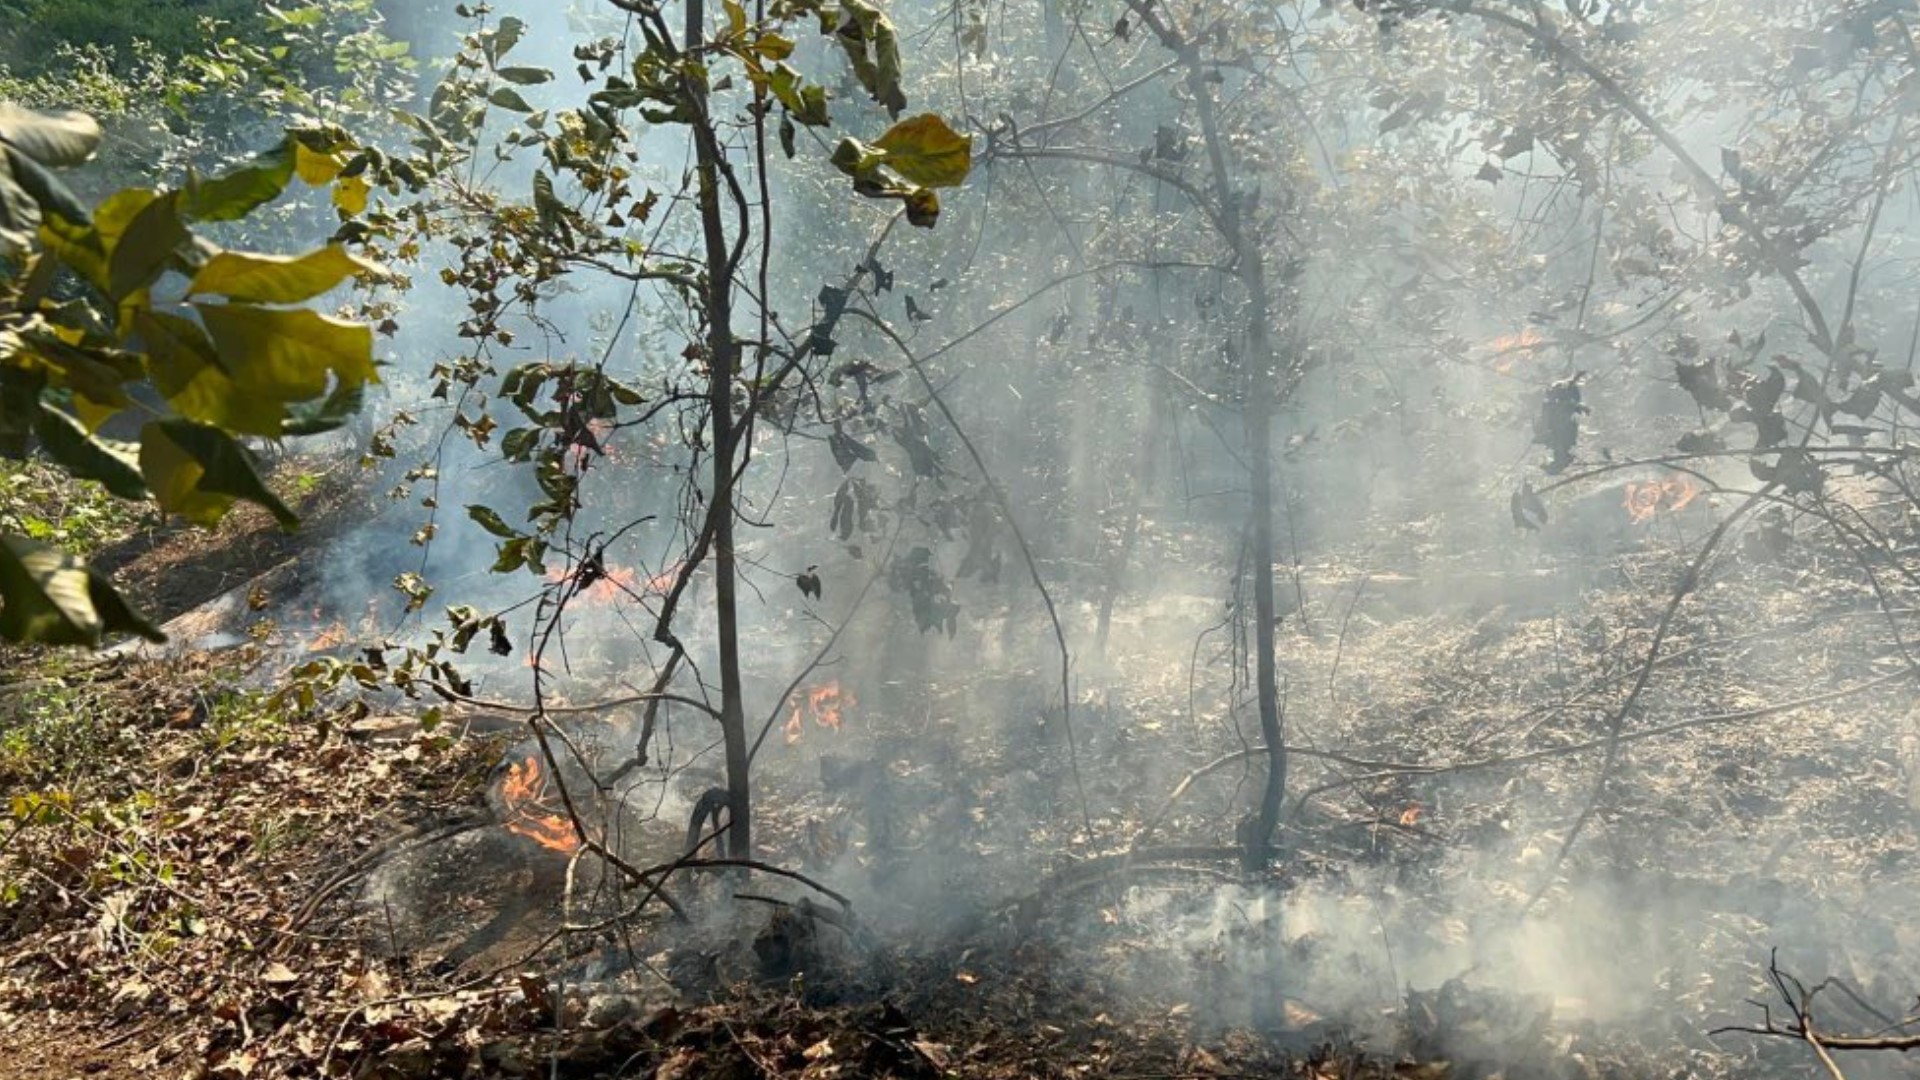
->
[172,2,1920,1068]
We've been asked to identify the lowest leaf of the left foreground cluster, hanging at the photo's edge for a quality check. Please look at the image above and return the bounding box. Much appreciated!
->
[0,534,167,646]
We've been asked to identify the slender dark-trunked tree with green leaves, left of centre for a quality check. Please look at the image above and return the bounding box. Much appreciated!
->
[309,0,972,857]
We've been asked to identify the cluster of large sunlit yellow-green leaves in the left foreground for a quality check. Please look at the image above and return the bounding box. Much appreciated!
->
[0,106,385,644]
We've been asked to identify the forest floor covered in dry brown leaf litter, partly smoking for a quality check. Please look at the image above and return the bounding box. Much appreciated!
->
[0,457,1920,1080]
